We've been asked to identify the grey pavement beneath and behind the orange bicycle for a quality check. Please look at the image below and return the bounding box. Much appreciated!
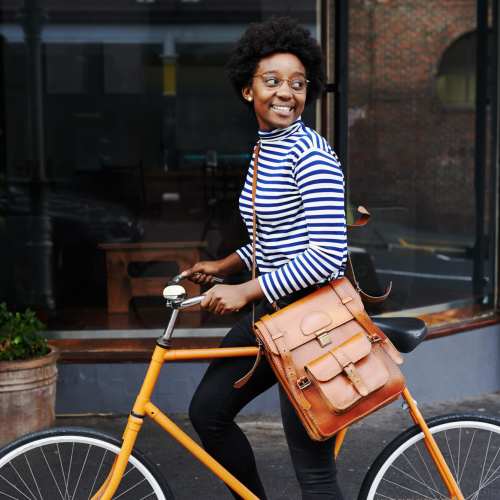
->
[56,393,500,500]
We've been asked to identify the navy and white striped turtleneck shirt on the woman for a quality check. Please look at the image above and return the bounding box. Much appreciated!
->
[236,119,347,302]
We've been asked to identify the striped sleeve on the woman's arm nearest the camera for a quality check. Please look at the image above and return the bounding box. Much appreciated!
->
[258,148,347,302]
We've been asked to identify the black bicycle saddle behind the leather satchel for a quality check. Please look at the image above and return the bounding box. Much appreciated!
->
[372,317,427,352]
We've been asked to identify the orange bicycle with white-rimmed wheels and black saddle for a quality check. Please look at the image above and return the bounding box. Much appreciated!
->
[0,275,500,500]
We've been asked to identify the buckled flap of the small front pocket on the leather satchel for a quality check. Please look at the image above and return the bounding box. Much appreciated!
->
[305,332,371,382]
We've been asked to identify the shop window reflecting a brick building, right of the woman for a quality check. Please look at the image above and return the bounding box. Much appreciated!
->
[348,0,497,325]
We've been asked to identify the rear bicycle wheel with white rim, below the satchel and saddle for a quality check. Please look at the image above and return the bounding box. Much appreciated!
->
[359,415,500,500]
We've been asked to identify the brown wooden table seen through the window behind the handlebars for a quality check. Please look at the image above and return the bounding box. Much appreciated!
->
[99,241,206,313]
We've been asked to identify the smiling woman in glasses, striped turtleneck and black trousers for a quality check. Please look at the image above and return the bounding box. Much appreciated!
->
[184,18,347,499]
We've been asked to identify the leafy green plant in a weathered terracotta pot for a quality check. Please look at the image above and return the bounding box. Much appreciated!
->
[0,303,58,445]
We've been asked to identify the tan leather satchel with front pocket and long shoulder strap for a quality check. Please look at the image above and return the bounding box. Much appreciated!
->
[247,142,405,441]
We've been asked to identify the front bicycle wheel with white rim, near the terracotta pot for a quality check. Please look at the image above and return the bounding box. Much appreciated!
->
[0,427,173,500]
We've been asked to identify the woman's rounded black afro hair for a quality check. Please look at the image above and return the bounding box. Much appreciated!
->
[226,17,325,104]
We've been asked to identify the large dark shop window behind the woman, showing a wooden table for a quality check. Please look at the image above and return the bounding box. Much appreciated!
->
[0,0,320,333]
